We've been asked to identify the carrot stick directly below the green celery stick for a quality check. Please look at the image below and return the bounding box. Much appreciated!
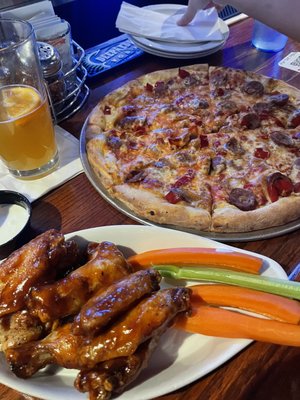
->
[190,284,300,325]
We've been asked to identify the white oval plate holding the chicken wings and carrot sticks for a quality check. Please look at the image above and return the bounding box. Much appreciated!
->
[0,225,287,400]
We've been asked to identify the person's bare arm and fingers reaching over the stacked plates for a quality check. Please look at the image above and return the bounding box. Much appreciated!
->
[179,0,300,41]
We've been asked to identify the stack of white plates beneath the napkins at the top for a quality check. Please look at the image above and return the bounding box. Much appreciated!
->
[128,4,229,59]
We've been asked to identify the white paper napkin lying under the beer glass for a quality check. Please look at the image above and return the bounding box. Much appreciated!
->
[0,126,83,202]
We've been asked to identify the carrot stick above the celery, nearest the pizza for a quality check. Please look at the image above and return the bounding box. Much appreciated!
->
[128,247,263,274]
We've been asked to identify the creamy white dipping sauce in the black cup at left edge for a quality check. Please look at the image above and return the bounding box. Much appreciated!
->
[0,204,29,246]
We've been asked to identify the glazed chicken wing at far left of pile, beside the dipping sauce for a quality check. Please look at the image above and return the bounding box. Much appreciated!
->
[0,229,79,317]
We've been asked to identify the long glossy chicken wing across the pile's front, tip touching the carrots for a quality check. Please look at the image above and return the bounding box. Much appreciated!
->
[6,288,190,378]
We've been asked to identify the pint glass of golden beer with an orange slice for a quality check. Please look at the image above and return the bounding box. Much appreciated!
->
[0,19,58,179]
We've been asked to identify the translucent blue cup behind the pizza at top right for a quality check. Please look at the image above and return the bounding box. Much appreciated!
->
[252,21,288,53]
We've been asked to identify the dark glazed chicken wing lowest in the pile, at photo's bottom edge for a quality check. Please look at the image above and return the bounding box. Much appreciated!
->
[74,336,159,400]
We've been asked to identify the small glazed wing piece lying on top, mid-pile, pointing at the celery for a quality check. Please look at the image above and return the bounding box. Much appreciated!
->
[73,269,161,336]
